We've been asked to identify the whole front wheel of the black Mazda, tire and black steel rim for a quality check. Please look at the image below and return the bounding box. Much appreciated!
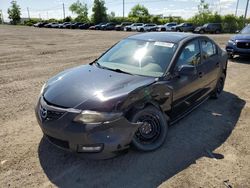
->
[131,106,168,152]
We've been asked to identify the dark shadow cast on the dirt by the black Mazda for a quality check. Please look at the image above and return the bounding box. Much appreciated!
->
[38,92,246,188]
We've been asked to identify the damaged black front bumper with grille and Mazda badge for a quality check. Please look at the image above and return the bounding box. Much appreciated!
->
[35,97,140,158]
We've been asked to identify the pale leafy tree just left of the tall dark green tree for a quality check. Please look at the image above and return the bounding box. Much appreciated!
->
[69,0,89,22]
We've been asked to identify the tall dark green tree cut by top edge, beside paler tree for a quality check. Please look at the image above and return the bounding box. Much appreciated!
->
[92,0,108,24]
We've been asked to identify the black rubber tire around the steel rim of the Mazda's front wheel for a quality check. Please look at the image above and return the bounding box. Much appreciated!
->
[131,106,168,151]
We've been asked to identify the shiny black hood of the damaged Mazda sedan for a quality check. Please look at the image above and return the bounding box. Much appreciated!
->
[43,65,155,108]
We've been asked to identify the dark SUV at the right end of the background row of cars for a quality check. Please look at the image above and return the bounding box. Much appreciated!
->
[194,23,222,34]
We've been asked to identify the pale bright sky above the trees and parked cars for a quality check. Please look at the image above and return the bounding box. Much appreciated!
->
[0,0,250,21]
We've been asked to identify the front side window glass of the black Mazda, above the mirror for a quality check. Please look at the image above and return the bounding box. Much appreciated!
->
[176,40,200,69]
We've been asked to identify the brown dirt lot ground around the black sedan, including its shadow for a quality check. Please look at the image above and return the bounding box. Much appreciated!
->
[0,26,250,188]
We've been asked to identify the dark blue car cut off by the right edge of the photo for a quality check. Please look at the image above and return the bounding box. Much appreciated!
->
[226,25,250,58]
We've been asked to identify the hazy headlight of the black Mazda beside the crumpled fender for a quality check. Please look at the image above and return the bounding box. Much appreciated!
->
[74,110,122,124]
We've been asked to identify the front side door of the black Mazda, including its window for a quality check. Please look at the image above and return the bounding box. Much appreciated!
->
[169,39,202,119]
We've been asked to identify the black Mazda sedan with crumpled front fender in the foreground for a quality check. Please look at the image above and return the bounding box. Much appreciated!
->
[35,32,227,158]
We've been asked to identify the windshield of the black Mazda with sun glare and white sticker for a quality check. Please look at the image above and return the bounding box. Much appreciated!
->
[98,39,177,77]
